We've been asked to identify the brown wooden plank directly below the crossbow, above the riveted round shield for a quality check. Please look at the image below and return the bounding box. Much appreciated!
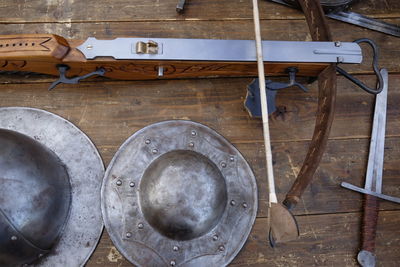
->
[0,75,400,142]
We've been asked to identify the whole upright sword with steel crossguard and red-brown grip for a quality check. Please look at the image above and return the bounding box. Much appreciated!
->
[341,69,400,267]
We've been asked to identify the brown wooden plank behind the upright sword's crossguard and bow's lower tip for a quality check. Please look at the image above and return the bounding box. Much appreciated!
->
[245,138,400,217]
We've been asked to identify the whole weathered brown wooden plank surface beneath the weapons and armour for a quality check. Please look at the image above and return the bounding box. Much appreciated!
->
[0,0,400,267]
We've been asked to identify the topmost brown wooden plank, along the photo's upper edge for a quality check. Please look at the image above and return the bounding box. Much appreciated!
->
[0,0,400,23]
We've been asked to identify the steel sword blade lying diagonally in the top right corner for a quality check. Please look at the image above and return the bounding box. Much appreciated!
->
[326,11,400,37]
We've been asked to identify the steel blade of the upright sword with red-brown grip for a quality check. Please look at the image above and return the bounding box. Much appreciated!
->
[365,69,388,193]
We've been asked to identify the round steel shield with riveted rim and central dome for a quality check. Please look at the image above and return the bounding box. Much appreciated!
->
[102,120,257,266]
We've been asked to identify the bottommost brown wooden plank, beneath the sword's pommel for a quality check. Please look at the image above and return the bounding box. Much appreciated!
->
[86,211,400,267]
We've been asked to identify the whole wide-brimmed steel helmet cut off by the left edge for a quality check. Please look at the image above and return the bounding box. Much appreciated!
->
[0,108,104,266]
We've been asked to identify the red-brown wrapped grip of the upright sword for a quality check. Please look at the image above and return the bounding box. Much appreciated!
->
[361,194,379,253]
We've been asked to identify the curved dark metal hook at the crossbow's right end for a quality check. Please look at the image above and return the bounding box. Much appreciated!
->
[336,38,383,95]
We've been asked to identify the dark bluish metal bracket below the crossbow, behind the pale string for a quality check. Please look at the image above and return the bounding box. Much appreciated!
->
[244,67,308,117]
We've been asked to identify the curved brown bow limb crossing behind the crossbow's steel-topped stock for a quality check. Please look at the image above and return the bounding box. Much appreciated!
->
[283,0,336,209]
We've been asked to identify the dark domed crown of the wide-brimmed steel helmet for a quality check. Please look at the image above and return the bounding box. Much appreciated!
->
[0,129,71,266]
